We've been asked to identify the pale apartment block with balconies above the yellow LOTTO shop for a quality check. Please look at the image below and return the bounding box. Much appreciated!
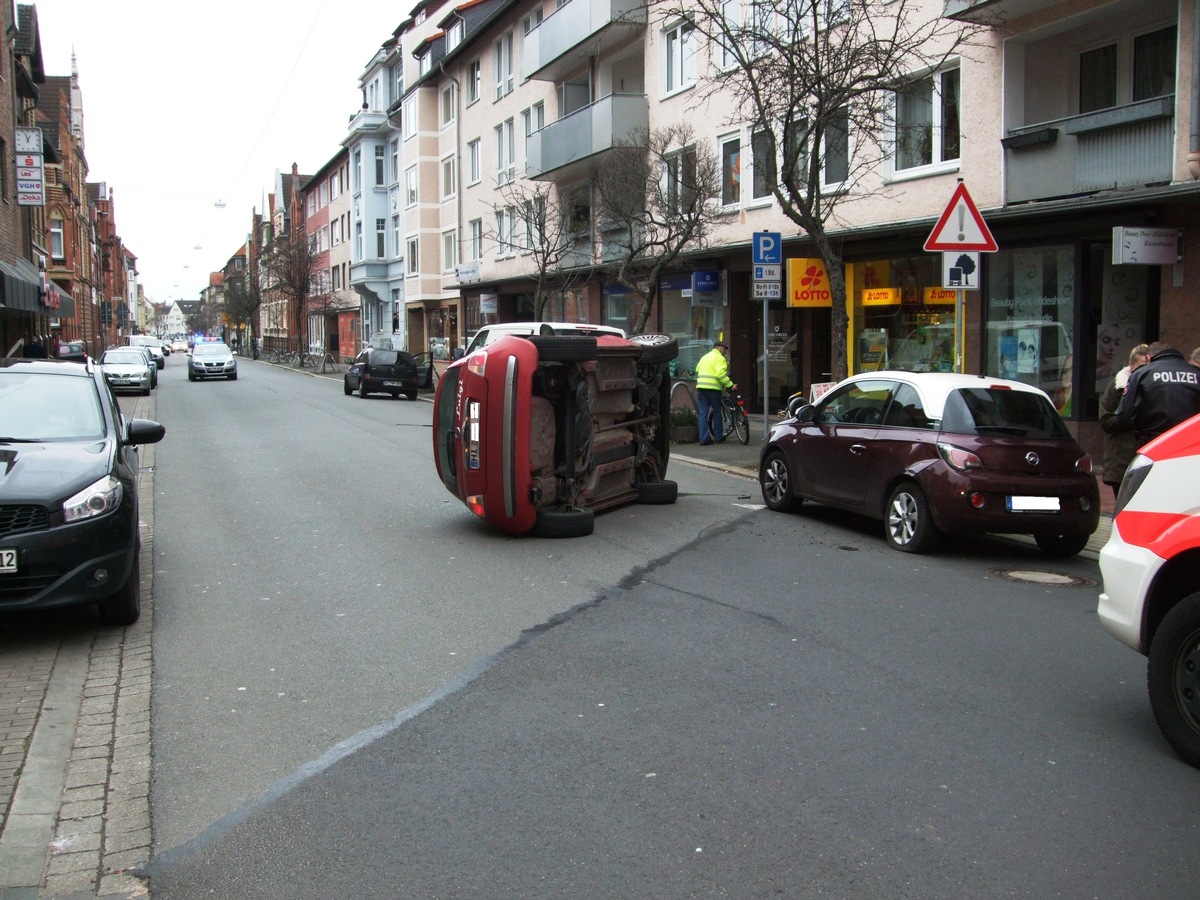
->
[388,0,1200,460]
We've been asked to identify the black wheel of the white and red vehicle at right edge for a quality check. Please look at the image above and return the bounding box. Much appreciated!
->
[1146,593,1200,768]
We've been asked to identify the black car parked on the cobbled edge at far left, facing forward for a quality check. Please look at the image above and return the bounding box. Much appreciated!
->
[0,359,166,625]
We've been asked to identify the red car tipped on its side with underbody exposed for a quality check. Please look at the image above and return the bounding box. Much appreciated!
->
[433,334,679,538]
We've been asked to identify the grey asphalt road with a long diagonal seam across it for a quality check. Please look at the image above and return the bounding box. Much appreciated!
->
[142,355,1200,900]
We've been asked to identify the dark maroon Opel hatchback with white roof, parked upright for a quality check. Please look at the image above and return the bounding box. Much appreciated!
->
[758,372,1100,557]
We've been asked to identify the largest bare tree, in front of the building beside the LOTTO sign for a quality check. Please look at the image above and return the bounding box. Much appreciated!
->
[650,0,980,379]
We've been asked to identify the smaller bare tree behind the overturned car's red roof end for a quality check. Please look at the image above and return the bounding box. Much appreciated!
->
[492,180,592,322]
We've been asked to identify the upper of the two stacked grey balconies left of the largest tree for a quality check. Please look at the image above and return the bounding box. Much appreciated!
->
[521,0,646,82]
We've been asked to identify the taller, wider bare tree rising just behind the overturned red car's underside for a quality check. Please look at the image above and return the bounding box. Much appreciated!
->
[592,122,720,334]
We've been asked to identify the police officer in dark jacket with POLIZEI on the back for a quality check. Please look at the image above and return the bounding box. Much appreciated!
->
[1115,341,1200,446]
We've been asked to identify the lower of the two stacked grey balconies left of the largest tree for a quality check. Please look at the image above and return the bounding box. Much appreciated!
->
[527,93,650,180]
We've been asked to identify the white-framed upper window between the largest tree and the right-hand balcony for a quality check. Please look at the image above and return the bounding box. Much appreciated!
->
[895,68,959,172]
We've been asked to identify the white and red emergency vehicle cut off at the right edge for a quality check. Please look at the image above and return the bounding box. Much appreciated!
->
[1098,415,1200,767]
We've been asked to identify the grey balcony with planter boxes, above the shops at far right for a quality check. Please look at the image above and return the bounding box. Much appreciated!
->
[1001,95,1175,203]
